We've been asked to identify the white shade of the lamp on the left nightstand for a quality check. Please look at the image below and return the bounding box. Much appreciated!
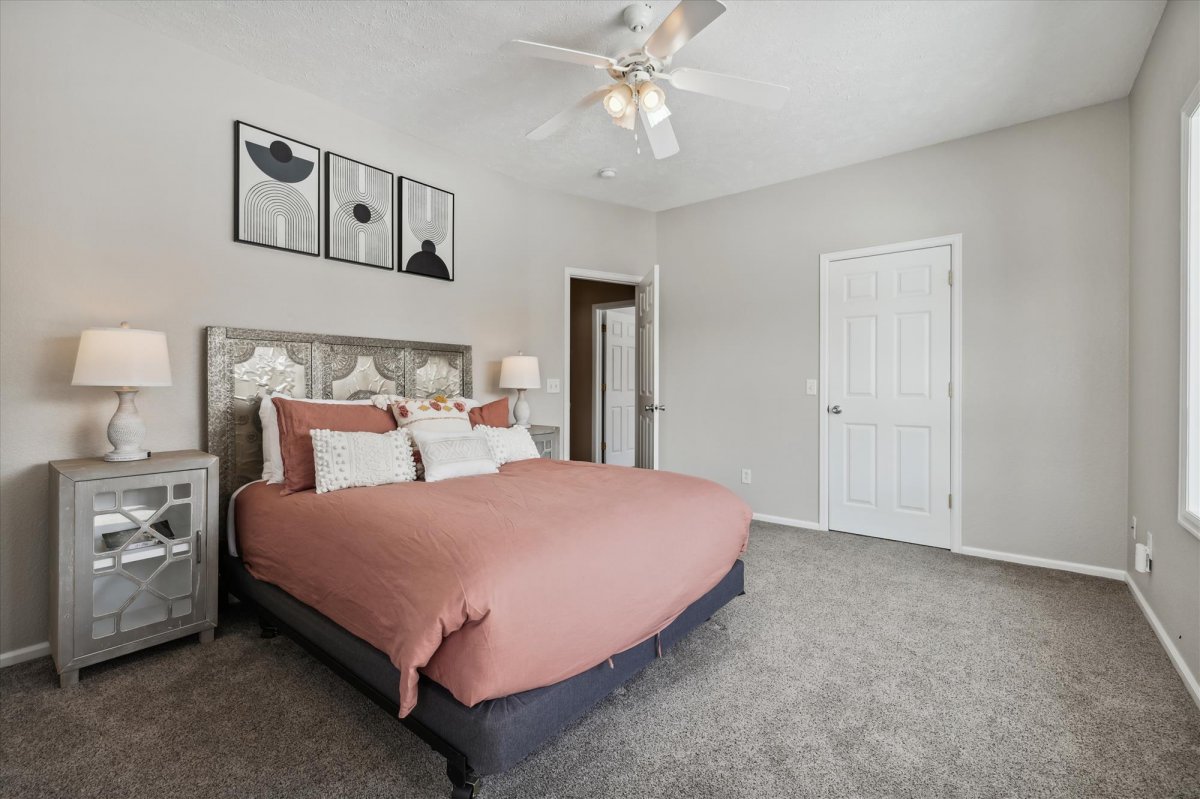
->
[71,323,170,389]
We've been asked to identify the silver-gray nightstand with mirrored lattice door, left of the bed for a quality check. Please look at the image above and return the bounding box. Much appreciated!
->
[50,450,217,687]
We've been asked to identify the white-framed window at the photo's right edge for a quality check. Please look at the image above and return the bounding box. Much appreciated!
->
[1180,84,1200,537]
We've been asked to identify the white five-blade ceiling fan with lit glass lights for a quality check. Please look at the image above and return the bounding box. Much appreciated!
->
[505,0,788,158]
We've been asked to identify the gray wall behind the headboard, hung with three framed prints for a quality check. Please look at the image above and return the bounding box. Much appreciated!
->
[0,2,654,651]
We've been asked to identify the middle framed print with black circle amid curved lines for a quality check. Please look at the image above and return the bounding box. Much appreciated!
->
[325,152,395,270]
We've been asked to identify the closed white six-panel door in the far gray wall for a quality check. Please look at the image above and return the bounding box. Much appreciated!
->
[824,245,952,548]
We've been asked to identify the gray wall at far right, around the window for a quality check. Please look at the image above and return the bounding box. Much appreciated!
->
[1124,1,1200,677]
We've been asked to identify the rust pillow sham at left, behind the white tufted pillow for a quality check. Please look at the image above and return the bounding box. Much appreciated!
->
[271,397,396,494]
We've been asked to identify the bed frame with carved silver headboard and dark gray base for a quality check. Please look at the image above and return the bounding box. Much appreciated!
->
[208,328,744,799]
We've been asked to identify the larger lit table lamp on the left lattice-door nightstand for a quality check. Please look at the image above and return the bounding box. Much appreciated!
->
[71,322,170,461]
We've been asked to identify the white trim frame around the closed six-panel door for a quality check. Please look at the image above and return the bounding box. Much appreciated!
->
[817,233,962,552]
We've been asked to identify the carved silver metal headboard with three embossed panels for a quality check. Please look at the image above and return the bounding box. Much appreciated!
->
[208,328,472,527]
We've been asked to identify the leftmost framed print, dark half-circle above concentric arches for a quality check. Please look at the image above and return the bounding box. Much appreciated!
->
[233,121,320,256]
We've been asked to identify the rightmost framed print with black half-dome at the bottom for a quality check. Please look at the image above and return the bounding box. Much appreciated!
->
[398,178,454,281]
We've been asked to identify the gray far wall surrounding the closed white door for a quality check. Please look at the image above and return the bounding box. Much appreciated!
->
[658,100,1129,569]
